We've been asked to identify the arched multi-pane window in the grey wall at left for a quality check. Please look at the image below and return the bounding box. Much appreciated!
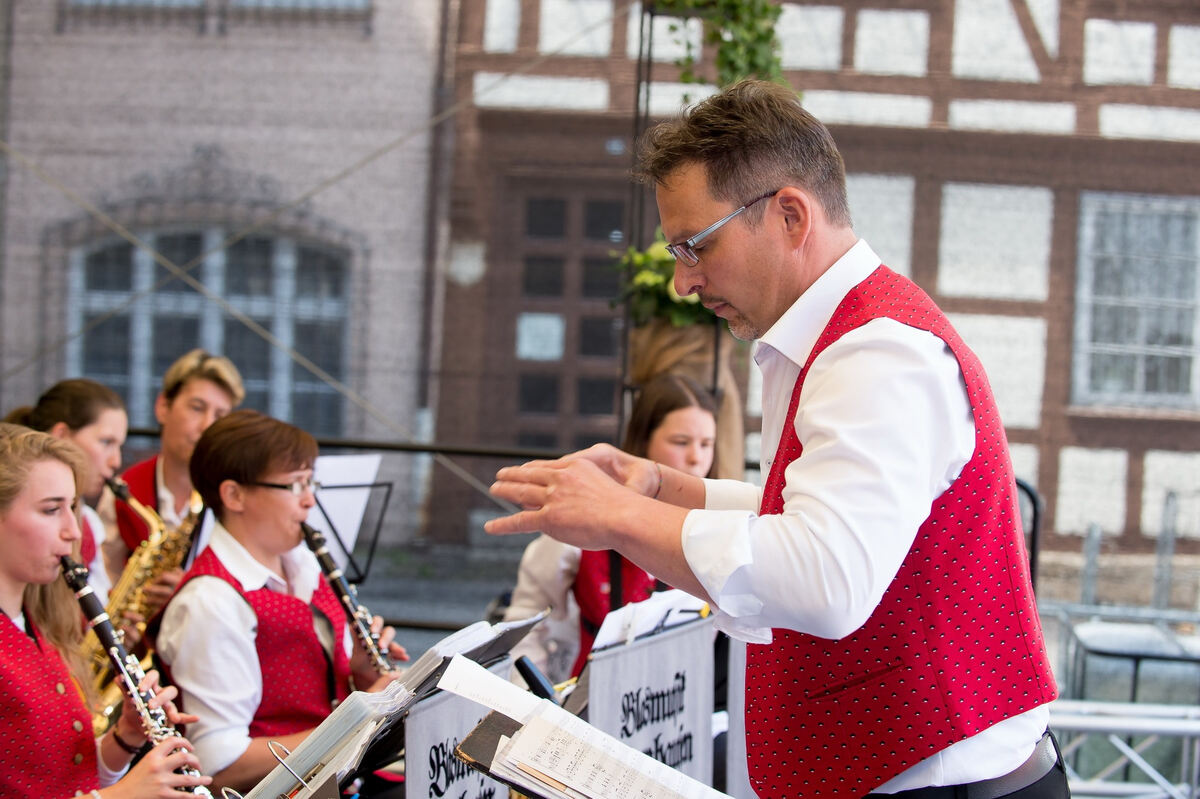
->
[67,227,349,437]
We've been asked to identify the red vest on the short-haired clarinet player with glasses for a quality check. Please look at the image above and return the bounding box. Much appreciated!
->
[179,547,350,738]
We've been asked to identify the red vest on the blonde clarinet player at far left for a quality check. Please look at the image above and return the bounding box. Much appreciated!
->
[0,614,100,797]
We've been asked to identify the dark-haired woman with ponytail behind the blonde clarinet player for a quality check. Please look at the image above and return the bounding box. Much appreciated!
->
[5,378,129,604]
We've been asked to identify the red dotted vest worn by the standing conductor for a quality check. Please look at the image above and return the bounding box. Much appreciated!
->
[746,266,1056,799]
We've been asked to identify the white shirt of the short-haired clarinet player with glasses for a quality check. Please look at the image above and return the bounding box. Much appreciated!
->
[157,523,352,774]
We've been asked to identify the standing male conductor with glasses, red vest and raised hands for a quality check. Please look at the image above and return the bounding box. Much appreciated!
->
[487,82,1069,799]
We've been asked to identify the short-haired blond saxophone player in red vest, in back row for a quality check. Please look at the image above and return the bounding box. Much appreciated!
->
[104,349,246,613]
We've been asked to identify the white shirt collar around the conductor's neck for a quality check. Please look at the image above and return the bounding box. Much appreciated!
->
[754,239,880,366]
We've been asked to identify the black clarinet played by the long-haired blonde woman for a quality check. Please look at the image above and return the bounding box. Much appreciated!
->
[62,557,212,799]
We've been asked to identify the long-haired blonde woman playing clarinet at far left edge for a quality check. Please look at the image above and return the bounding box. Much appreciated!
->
[0,423,210,799]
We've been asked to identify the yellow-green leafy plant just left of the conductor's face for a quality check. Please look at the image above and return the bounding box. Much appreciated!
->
[614,228,716,328]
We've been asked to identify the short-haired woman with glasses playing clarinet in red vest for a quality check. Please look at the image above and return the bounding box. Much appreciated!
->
[157,410,407,791]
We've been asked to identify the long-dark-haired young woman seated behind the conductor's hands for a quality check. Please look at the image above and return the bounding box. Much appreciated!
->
[504,374,716,681]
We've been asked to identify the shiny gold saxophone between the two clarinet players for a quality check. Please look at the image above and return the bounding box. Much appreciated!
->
[84,477,204,734]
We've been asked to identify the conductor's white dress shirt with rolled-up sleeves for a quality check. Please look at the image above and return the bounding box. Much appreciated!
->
[683,240,1049,793]
